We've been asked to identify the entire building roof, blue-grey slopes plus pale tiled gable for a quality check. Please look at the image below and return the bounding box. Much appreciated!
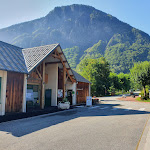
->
[0,41,91,83]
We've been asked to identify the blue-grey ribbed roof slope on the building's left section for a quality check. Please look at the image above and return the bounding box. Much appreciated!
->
[0,41,28,73]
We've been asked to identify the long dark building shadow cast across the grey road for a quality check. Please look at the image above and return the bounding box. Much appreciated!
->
[0,104,150,137]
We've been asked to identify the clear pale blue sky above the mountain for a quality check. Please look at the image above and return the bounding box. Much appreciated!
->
[0,0,150,35]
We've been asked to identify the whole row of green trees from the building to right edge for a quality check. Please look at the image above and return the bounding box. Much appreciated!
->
[76,57,150,96]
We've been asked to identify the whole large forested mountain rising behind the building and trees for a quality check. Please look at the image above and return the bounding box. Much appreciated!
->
[0,5,150,73]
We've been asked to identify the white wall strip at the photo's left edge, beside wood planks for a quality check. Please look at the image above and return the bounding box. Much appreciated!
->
[0,70,7,115]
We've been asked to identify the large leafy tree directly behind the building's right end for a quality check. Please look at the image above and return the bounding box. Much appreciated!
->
[77,57,110,96]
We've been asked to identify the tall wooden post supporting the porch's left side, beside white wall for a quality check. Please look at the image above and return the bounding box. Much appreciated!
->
[40,60,45,109]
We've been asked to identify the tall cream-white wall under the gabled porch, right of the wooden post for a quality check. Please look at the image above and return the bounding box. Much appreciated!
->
[45,64,58,106]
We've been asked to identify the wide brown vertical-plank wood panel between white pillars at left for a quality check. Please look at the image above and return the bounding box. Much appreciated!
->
[5,72,24,112]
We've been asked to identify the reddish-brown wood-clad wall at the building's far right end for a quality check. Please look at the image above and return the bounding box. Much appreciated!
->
[77,82,89,104]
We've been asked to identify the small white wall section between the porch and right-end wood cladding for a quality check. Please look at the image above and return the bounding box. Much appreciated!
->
[66,81,77,105]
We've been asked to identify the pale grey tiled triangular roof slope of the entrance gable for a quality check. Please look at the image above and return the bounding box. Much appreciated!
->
[22,44,59,72]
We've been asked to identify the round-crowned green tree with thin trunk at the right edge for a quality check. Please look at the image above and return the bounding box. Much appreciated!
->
[130,61,150,97]
